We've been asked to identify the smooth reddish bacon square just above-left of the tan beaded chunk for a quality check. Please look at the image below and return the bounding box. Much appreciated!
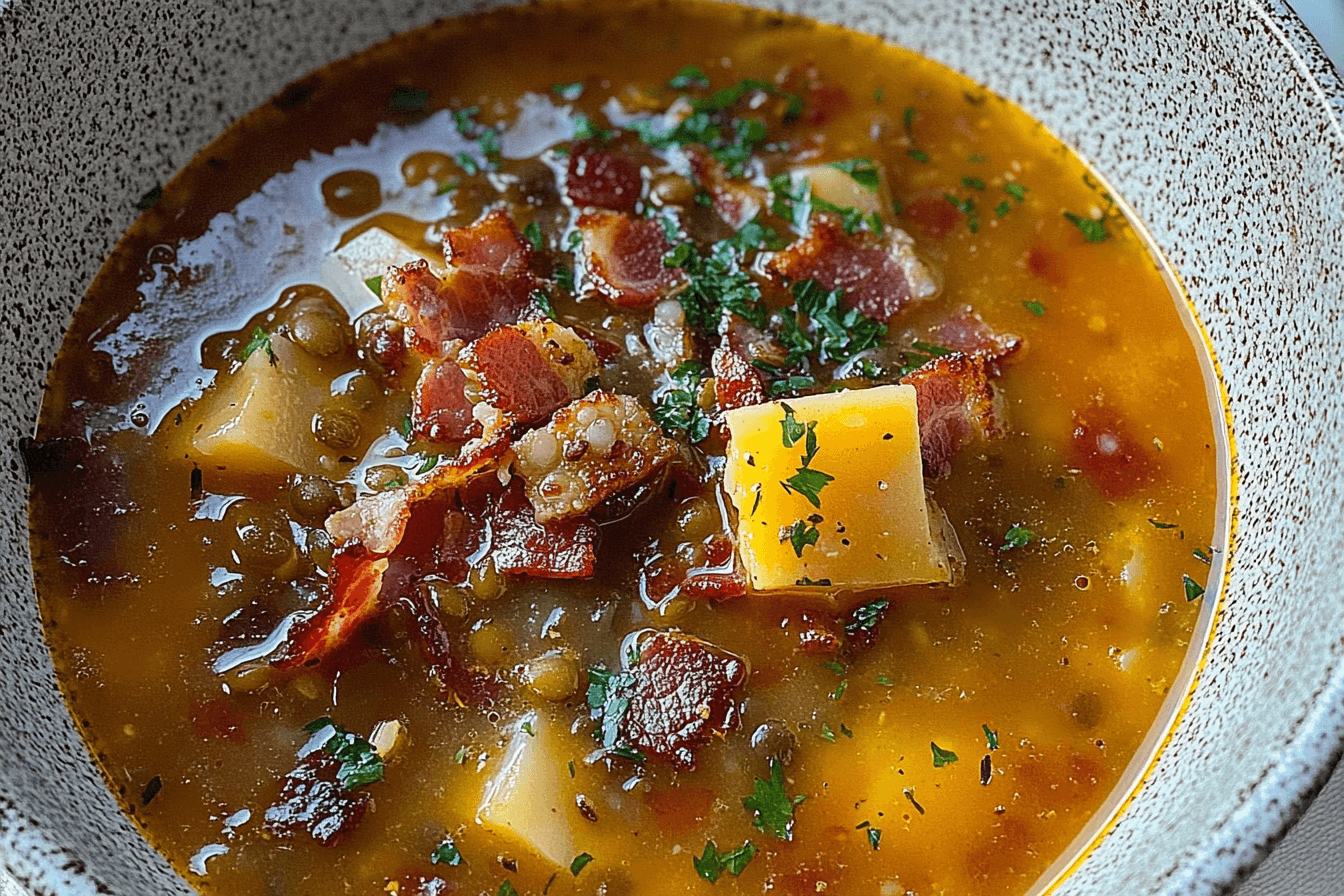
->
[460,326,571,423]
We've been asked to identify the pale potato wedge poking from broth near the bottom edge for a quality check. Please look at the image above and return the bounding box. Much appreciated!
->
[476,712,589,865]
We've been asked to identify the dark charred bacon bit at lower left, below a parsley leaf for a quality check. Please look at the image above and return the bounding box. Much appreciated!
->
[266,750,372,846]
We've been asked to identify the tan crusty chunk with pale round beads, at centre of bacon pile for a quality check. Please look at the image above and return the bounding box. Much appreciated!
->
[513,392,676,523]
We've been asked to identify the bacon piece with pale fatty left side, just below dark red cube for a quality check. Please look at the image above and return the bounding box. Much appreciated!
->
[577,212,685,308]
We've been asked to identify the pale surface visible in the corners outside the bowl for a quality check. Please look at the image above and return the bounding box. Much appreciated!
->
[0,0,1344,896]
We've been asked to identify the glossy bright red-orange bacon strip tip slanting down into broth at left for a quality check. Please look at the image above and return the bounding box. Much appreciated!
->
[271,548,387,669]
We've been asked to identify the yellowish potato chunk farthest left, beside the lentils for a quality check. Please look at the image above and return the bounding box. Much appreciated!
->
[188,336,331,474]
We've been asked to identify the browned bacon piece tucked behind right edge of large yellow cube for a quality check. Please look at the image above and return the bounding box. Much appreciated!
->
[900,352,1003,478]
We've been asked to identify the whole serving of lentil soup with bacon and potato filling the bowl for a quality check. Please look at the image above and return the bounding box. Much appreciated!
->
[26,3,1226,896]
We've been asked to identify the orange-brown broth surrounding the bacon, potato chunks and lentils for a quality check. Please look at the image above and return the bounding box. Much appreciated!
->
[32,3,1226,896]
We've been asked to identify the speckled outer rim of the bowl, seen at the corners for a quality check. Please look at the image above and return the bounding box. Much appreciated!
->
[0,0,1344,896]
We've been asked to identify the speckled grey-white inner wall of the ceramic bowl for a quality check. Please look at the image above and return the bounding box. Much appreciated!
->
[0,0,1344,896]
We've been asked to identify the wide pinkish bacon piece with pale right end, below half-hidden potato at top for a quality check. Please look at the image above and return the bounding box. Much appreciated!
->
[766,215,938,321]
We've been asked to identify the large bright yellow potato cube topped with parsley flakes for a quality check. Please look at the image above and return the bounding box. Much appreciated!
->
[723,386,960,592]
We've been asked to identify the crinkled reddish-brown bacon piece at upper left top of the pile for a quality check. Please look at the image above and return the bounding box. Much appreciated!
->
[383,210,536,357]
